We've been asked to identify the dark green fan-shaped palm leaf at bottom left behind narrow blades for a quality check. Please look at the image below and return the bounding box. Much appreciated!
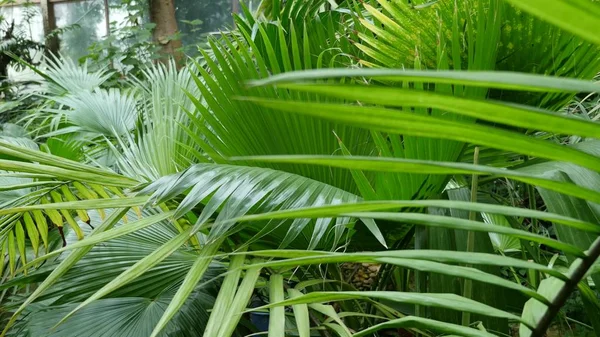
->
[8,212,222,336]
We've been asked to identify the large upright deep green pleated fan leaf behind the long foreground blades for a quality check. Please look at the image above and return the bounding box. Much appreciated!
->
[190,6,374,192]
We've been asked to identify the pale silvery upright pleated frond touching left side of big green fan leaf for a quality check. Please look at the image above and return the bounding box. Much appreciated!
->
[111,61,203,181]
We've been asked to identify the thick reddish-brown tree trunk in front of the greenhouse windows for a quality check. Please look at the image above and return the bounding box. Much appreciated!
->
[150,0,183,67]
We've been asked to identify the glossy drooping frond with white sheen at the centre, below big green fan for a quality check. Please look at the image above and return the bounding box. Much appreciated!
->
[139,164,366,248]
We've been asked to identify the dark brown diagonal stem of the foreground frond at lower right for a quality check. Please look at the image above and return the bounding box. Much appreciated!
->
[531,237,600,337]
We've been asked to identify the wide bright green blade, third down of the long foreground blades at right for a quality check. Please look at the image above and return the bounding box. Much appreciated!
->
[245,98,600,171]
